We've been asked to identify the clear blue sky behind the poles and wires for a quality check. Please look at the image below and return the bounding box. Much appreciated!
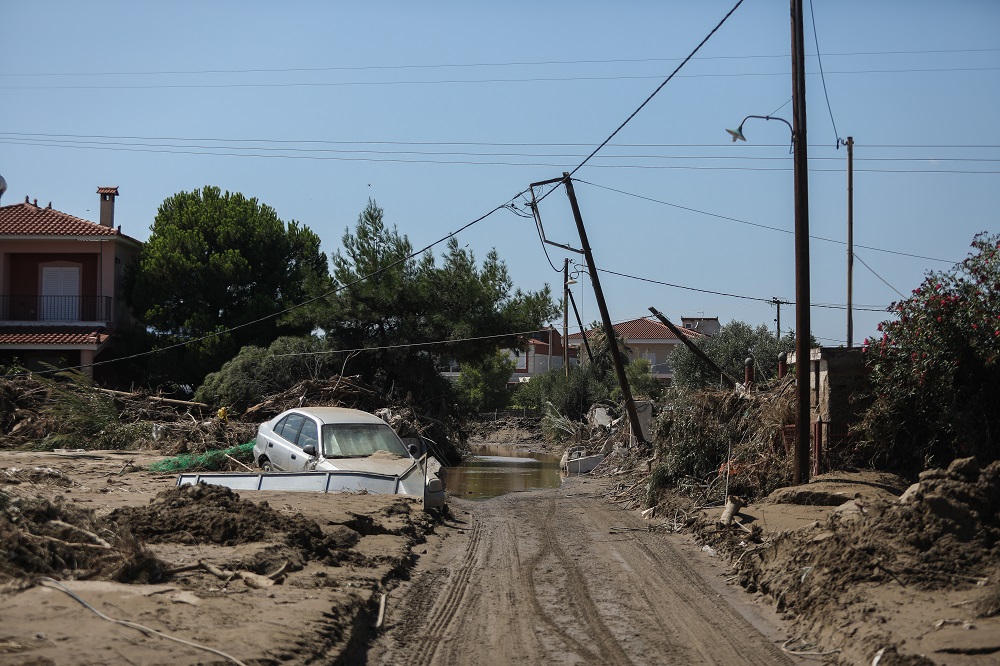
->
[0,0,1000,345]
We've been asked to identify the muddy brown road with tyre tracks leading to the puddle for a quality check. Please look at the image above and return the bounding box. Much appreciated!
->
[367,479,795,666]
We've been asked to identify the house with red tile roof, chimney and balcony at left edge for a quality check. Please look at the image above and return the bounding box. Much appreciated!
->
[0,187,142,374]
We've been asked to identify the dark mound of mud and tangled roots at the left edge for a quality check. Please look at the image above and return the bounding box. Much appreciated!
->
[0,482,164,583]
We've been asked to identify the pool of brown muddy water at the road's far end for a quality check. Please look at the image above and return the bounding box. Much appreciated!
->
[443,444,560,499]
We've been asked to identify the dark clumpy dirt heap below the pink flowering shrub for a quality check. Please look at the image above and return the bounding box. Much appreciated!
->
[743,458,1000,613]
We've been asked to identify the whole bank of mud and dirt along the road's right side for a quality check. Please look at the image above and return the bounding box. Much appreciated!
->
[658,459,1000,666]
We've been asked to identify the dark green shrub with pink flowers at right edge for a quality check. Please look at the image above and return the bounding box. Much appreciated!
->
[859,232,1000,474]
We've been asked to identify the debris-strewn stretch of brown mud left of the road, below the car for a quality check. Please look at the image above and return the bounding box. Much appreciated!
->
[0,451,439,664]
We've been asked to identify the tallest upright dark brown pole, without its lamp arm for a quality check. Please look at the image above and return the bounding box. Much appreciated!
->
[790,0,812,484]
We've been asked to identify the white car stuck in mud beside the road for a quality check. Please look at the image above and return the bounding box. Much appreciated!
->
[253,407,445,507]
